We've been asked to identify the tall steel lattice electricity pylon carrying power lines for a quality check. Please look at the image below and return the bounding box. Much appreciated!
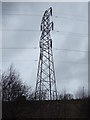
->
[35,7,57,100]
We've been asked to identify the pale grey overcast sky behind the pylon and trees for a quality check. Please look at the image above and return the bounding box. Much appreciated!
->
[2,2,88,93]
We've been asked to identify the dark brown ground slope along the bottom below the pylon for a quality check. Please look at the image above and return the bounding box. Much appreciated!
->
[2,99,88,118]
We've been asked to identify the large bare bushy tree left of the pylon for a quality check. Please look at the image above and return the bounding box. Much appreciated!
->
[2,65,31,101]
